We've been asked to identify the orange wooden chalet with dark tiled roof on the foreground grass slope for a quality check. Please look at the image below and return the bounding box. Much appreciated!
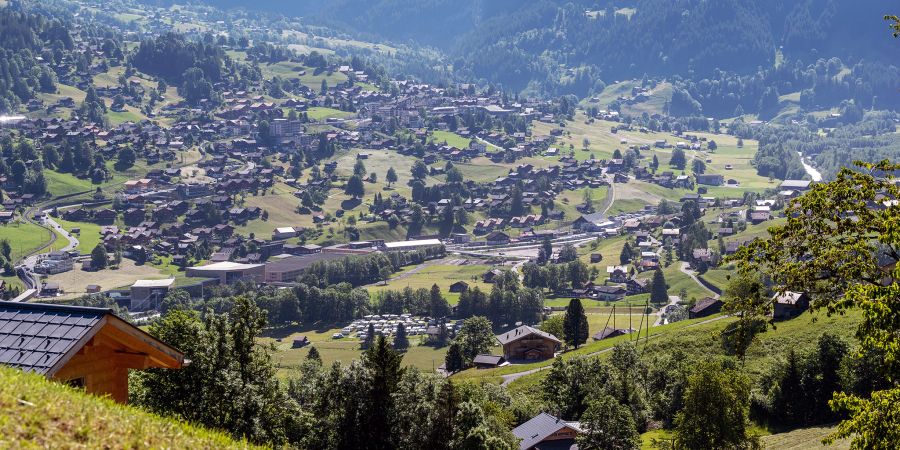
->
[0,302,185,403]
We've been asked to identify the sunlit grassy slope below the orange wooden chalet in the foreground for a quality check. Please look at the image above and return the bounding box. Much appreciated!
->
[0,367,256,449]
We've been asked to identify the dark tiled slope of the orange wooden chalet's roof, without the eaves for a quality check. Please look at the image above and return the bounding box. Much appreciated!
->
[0,302,112,374]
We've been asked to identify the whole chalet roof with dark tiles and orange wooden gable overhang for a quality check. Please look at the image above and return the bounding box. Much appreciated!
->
[0,301,184,375]
